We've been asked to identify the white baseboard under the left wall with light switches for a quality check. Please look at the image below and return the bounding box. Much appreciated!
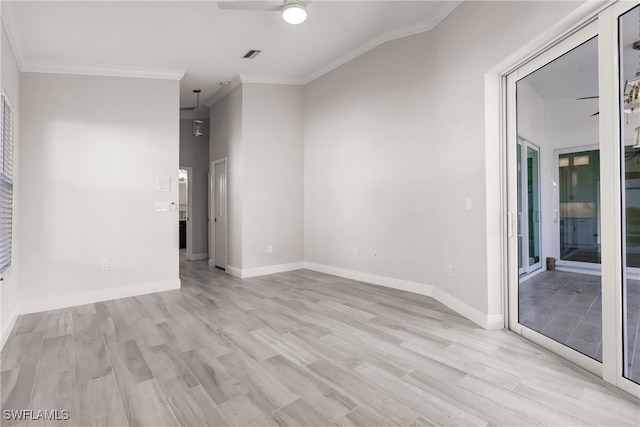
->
[19,279,180,314]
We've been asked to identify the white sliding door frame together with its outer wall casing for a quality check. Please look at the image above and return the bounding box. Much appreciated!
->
[502,0,640,397]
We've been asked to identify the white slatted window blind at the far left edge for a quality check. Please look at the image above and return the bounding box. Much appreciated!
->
[0,93,13,273]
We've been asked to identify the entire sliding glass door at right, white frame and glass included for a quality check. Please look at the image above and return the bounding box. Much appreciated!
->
[506,2,640,396]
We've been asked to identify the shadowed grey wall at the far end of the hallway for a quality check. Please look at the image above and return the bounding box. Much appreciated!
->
[180,119,209,259]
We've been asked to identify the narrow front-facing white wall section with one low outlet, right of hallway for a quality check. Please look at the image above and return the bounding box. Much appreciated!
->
[242,84,304,269]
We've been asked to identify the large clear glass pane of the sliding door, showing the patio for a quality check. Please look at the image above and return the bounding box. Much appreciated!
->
[515,37,602,364]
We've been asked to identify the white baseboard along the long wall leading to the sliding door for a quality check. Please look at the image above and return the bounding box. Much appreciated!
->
[304,262,504,330]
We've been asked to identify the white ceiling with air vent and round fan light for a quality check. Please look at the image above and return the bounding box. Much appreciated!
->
[2,0,461,115]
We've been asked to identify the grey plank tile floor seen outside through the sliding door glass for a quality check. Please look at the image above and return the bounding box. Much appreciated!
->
[519,270,640,383]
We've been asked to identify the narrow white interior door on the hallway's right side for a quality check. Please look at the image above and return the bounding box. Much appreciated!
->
[212,159,227,269]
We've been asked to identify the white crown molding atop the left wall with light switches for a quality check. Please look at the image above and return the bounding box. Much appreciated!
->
[20,61,185,81]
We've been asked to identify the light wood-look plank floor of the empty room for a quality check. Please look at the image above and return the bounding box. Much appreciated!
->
[1,261,640,427]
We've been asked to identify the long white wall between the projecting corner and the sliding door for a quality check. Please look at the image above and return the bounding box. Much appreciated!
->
[304,2,579,314]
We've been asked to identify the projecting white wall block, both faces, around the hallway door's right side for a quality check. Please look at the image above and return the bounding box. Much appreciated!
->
[209,83,304,277]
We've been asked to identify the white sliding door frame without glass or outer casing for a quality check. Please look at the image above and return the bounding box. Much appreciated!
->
[500,1,640,397]
